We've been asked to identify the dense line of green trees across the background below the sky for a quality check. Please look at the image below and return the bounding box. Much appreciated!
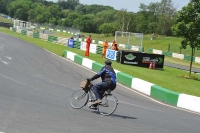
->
[0,0,177,36]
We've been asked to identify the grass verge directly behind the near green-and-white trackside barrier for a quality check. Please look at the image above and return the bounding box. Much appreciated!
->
[0,28,200,96]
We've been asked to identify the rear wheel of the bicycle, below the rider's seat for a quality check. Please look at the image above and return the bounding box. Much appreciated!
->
[97,94,118,115]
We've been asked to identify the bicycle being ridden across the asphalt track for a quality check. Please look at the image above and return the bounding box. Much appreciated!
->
[70,82,119,116]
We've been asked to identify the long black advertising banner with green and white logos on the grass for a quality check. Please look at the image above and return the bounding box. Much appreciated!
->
[119,51,164,68]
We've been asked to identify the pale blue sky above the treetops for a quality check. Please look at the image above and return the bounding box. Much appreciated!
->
[47,0,190,12]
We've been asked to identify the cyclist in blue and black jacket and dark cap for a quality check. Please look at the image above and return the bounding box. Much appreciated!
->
[87,60,116,105]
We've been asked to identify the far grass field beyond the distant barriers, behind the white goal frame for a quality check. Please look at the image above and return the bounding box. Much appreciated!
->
[55,32,200,57]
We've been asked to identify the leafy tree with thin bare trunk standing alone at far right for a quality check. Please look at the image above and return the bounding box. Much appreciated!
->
[172,0,200,77]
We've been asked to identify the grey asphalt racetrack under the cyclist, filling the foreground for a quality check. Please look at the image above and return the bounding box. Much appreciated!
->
[0,33,200,133]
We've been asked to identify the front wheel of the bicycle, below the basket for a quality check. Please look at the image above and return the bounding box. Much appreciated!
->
[70,89,89,109]
